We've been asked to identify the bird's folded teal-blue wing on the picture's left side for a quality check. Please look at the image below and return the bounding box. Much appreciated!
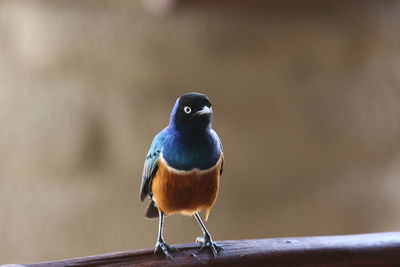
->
[140,131,165,201]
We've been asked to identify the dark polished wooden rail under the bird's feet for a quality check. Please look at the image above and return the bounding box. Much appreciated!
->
[4,232,400,267]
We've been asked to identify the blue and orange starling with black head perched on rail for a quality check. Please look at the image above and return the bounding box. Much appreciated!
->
[140,92,224,259]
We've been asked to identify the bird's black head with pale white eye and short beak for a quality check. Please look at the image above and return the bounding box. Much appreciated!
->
[170,93,212,131]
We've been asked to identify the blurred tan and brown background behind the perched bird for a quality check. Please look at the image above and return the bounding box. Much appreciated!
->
[0,0,400,263]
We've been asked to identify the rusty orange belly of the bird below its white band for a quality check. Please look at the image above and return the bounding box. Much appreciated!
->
[152,156,222,221]
